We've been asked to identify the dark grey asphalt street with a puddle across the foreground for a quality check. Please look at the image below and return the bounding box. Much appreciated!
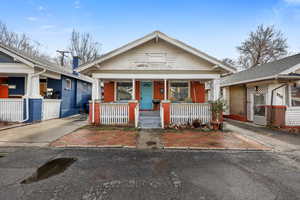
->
[0,148,300,200]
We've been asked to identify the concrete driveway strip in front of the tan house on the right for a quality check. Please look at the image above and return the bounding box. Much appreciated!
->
[225,120,300,152]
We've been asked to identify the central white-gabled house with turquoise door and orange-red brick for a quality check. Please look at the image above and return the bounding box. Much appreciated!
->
[77,31,235,126]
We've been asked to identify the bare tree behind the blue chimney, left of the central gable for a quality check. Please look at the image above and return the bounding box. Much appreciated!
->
[69,30,100,63]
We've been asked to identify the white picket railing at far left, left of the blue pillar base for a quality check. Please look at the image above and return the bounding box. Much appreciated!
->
[0,99,24,122]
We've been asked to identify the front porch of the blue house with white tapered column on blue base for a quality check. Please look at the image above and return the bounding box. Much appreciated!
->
[0,72,61,122]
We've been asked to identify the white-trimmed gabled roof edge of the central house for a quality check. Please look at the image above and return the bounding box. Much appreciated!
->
[77,31,236,73]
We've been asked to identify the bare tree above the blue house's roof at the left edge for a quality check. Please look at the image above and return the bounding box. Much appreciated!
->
[0,21,42,56]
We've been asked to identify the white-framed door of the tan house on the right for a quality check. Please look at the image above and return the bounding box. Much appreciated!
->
[253,93,267,126]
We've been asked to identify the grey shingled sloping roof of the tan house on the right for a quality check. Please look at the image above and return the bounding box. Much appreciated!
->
[221,54,300,86]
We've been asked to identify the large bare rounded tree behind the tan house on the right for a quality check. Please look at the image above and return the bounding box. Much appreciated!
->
[237,25,288,68]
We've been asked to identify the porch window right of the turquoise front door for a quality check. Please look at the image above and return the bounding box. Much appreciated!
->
[170,82,189,101]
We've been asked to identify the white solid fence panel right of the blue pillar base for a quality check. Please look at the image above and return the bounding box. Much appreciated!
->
[42,99,61,120]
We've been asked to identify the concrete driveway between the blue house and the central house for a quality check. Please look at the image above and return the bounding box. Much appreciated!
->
[0,115,87,147]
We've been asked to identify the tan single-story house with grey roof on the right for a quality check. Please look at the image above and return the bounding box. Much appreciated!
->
[221,54,300,128]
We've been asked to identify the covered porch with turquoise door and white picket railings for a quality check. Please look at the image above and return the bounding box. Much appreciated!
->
[90,73,220,128]
